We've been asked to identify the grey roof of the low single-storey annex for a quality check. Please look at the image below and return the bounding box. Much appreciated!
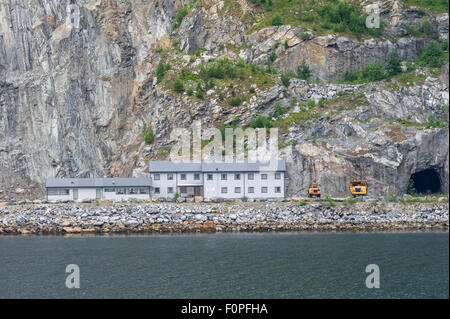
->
[45,177,152,188]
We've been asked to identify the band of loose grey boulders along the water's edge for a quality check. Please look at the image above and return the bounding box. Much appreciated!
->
[0,202,449,234]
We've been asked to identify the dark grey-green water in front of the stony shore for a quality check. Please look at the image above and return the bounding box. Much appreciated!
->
[0,232,449,298]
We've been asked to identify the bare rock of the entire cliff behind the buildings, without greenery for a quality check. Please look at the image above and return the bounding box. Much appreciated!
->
[0,0,449,200]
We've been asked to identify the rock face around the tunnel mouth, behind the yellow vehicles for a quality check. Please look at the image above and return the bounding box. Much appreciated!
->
[285,78,449,196]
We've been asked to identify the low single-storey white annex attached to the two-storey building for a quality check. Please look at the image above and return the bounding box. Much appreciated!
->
[45,178,152,201]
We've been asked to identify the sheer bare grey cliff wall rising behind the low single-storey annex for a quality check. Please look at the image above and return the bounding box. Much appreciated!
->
[0,0,181,189]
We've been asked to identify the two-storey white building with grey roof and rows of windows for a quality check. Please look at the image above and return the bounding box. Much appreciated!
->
[149,161,286,200]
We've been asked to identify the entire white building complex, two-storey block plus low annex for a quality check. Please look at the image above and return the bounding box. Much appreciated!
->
[45,161,286,201]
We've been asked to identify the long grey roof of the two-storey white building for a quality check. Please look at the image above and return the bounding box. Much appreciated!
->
[149,160,286,173]
